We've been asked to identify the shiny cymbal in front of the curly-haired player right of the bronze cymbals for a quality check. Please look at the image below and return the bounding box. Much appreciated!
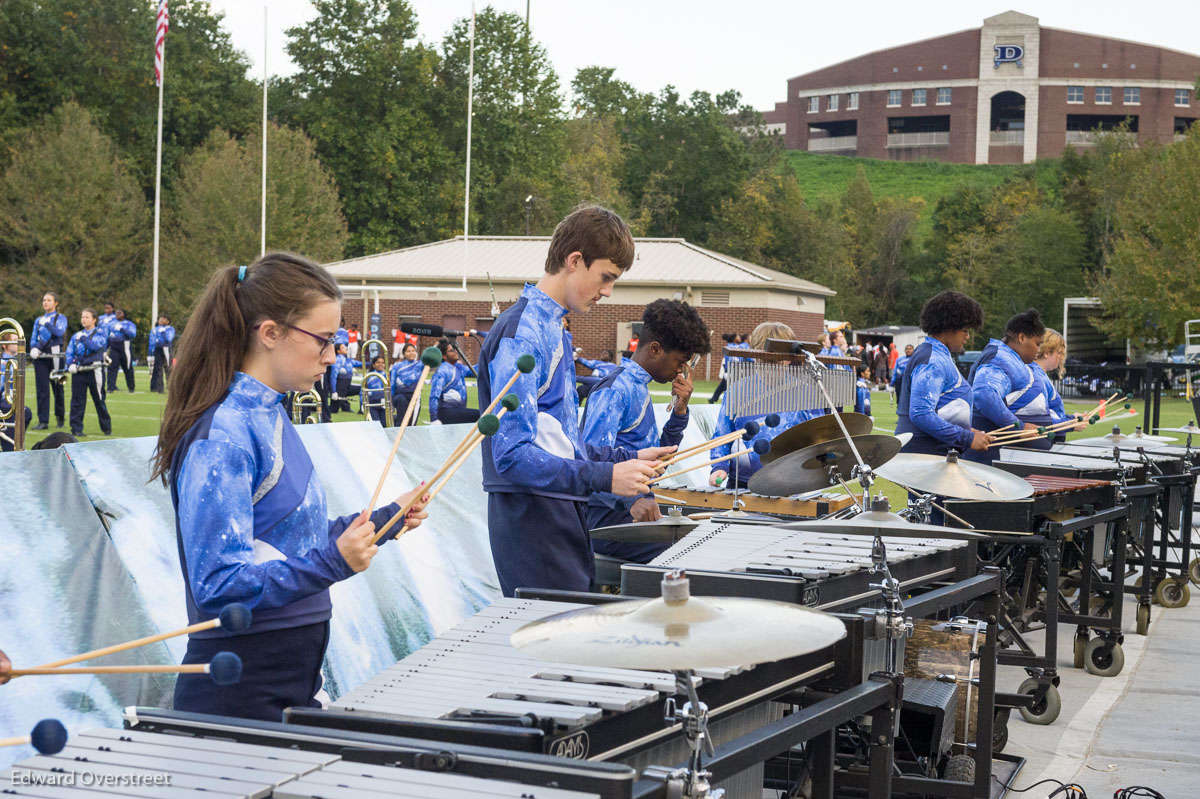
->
[875,452,1033,500]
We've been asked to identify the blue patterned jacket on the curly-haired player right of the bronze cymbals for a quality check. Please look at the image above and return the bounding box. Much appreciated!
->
[896,336,974,455]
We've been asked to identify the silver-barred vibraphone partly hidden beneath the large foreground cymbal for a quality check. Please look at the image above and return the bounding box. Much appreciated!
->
[286,589,838,799]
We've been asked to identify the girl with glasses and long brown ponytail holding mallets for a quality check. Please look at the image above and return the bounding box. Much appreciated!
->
[151,253,426,721]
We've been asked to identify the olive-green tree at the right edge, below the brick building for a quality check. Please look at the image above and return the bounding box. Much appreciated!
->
[1094,126,1200,349]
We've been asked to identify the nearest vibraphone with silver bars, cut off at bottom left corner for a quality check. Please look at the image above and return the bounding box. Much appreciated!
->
[0,710,619,799]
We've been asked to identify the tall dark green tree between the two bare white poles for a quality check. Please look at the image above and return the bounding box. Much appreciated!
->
[275,0,466,256]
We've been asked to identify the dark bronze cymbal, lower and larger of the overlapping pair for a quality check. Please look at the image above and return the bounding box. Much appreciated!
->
[746,431,900,497]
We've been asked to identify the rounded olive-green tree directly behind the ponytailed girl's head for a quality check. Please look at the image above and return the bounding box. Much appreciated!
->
[161,125,347,325]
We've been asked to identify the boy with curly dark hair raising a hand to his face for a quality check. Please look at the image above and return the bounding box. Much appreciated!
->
[581,300,710,563]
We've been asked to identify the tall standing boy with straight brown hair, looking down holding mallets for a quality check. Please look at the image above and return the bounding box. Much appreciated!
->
[479,205,672,596]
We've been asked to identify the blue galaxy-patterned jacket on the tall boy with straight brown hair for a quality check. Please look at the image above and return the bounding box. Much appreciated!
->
[479,286,636,500]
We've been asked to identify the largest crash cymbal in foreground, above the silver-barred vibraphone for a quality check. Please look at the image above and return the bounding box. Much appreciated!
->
[511,577,846,671]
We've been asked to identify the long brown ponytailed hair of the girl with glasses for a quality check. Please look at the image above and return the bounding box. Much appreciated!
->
[150,252,342,482]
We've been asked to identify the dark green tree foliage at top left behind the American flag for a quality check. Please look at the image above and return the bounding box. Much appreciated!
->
[0,0,259,189]
